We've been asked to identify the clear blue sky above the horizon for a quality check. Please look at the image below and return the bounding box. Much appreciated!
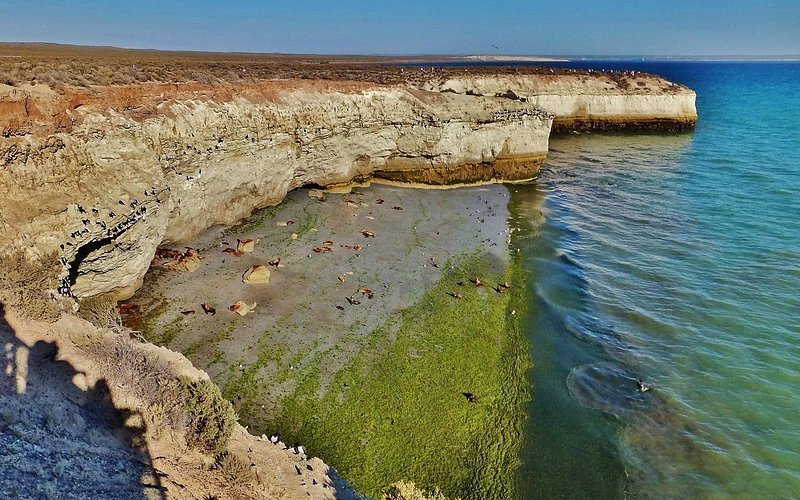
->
[0,0,800,55]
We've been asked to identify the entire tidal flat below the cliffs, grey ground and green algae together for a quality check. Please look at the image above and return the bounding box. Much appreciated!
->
[124,185,529,498]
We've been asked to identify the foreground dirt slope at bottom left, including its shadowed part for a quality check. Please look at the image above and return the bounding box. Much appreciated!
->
[0,298,358,499]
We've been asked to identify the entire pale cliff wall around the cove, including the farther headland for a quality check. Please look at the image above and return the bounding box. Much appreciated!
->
[0,74,695,297]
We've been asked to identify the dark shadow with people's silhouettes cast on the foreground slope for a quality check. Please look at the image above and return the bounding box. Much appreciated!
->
[0,302,166,499]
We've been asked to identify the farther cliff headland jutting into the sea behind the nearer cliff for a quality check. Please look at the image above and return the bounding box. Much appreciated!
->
[425,72,697,132]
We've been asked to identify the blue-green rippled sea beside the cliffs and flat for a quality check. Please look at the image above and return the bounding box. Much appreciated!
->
[511,61,800,498]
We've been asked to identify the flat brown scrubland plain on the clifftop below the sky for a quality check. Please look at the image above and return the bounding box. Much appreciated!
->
[0,43,644,89]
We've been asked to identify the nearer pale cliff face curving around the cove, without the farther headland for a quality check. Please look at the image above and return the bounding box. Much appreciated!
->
[0,85,552,296]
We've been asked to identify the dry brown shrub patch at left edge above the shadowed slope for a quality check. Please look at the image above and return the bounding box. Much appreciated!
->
[0,251,62,323]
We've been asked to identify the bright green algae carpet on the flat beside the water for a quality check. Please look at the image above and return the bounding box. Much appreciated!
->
[258,256,529,498]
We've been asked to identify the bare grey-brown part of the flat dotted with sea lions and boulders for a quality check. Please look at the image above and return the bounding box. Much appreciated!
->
[125,185,508,420]
